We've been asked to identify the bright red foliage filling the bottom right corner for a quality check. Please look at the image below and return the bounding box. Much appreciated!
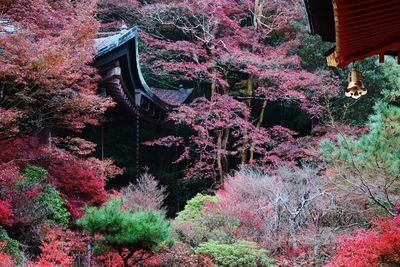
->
[325,216,400,267]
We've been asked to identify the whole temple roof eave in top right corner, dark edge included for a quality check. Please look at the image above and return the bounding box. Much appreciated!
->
[305,0,400,67]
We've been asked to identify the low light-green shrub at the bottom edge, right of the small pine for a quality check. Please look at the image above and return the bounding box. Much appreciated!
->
[194,240,275,267]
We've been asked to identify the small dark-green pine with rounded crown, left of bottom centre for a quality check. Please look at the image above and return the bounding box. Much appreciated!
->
[78,197,171,266]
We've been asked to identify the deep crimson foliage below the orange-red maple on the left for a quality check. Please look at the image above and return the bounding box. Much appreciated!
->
[0,137,109,220]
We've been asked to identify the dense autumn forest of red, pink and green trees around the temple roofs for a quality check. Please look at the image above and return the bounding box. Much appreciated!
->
[0,0,400,267]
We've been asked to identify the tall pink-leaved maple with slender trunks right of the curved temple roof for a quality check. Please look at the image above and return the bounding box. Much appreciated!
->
[129,0,338,184]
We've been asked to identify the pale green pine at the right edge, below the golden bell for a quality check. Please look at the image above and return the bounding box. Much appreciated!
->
[321,101,400,215]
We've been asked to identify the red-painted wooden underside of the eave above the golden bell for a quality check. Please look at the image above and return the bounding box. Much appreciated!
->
[335,0,400,67]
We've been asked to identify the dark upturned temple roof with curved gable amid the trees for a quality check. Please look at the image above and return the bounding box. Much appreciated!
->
[94,27,193,120]
